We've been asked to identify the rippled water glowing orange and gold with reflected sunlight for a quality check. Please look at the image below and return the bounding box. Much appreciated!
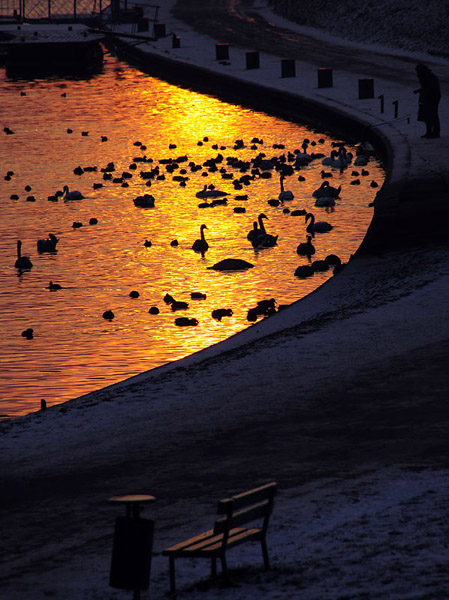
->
[0,49,384,416]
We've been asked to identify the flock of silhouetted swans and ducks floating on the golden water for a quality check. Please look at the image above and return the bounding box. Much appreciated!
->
[5,131,377,337]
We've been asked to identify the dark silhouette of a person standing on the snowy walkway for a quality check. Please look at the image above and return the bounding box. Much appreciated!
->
[414,64,441,138]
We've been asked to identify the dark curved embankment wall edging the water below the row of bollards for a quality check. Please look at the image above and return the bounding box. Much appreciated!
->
[107,25,449,254]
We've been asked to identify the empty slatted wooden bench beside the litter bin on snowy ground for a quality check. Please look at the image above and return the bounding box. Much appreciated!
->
[162,482,277,594]
